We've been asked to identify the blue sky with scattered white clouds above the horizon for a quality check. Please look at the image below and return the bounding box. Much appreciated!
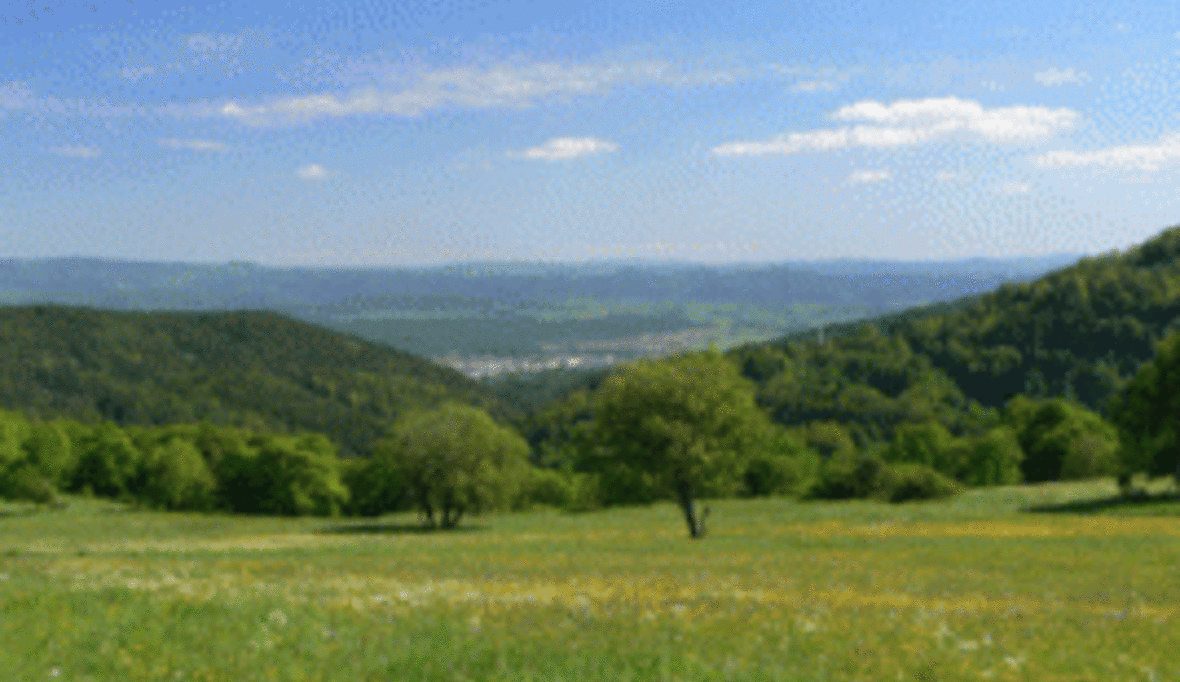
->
[0,0,1180,268]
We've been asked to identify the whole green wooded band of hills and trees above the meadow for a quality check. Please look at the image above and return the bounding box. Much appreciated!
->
[0,228,1180,519]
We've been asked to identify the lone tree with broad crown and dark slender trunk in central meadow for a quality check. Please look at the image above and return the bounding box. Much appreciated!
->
[594,347,769,538]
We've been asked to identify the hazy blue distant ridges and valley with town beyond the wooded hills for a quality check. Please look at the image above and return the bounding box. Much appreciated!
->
[0,254,1081,376]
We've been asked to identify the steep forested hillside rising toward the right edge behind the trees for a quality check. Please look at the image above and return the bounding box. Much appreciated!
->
[519,228,1180,471]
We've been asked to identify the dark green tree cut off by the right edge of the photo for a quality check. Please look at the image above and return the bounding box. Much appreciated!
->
[1108,333,1180,488]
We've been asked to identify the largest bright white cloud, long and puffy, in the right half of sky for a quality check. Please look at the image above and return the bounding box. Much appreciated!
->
[713,97,1079,156]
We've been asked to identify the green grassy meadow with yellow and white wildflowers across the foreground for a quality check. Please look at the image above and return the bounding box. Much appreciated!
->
[0,481,1180,682]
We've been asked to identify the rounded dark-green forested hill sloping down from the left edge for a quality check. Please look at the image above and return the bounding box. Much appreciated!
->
[0,304,510,455]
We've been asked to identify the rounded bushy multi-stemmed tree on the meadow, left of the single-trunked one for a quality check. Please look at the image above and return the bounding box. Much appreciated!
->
[371,401,529,529]
